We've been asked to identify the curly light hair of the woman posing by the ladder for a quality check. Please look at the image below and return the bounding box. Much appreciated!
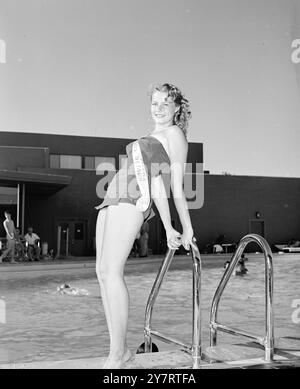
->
[148,83,192,137]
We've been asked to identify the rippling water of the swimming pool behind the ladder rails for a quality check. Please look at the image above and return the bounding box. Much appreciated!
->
[0,254,300,363]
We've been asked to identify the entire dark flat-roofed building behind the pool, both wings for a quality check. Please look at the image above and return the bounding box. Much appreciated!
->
[0,132,300,256]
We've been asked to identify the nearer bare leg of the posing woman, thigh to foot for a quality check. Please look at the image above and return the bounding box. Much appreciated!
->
[97,203,143,369]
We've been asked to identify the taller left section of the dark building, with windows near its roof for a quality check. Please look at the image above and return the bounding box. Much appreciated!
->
[0,132,202,256]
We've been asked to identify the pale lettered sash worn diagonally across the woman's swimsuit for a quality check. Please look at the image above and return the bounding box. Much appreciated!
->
[132,140,150,212]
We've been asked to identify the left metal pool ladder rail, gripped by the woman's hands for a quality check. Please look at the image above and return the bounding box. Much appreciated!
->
[144,238,201,369]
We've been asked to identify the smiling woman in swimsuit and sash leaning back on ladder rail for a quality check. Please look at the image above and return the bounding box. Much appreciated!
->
[96,84,193,369]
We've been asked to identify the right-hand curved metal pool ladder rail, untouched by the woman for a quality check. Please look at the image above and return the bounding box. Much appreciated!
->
[210,234,274,362]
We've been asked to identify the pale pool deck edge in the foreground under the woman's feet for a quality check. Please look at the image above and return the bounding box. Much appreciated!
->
[0,338,300,369]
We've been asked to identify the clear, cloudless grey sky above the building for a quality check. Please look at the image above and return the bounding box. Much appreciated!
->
[0,0,300,177]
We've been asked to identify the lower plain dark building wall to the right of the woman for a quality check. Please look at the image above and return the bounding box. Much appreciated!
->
[186,175,300,250]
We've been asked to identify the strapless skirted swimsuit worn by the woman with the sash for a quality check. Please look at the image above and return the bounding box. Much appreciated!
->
[96,135,170,221]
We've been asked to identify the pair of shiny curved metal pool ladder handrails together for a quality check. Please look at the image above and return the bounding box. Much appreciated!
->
[144,234,274,369]
